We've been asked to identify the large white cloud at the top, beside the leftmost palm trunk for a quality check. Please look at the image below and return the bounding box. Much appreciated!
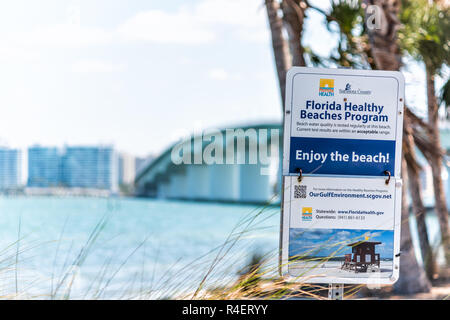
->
[118,0,269,44]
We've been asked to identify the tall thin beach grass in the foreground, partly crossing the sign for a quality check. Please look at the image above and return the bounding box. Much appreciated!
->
[0,198,442,300]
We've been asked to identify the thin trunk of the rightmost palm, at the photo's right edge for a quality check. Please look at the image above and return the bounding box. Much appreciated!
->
[425,66,450,262]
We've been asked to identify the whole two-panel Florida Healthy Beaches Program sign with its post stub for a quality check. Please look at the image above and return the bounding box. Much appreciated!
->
[280,67,404,298]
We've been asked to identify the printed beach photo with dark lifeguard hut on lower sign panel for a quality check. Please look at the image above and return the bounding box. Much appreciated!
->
[288,229,394,278]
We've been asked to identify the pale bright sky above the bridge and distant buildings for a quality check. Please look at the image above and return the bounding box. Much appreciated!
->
[0,0,442,160]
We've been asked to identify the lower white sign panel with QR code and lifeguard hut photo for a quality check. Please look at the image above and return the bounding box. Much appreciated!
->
[281,177,402,284]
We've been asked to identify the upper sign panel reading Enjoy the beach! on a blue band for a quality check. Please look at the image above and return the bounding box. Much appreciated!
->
[283,67,404,178]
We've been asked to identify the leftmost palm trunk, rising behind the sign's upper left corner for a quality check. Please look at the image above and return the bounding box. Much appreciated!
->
[265,0,292,114]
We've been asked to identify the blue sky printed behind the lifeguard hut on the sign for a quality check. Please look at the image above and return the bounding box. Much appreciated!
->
[289,228,394,258]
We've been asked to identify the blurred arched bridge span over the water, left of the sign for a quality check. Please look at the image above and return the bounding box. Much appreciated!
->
[135,123,283,203]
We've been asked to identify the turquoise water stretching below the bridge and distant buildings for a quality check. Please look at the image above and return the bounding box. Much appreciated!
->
[0,197,279,299]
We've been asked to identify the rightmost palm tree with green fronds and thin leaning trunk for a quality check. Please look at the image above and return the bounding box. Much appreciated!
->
[401,0,450,262]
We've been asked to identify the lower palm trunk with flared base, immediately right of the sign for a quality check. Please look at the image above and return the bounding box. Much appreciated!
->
[394,158,431,294]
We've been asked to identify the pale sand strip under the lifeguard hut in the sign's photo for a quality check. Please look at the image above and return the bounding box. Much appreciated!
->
[289,261,392,278]
